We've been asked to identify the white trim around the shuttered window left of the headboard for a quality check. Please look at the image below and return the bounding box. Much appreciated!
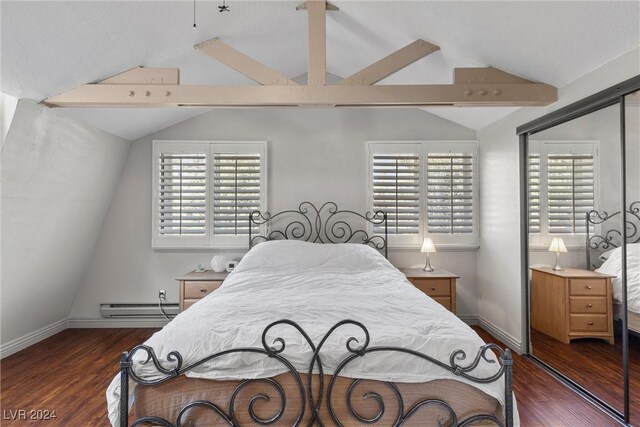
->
[151,140,269,250]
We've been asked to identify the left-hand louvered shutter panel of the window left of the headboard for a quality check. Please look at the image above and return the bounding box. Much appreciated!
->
[156,153,207,236]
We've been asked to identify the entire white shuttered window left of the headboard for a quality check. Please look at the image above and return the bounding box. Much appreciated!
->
[153,141,266,248]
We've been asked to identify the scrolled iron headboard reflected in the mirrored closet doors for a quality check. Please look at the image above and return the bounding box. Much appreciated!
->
[586,200,640,269]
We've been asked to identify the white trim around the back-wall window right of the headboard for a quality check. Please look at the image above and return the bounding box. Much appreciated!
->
[366,140,480,251]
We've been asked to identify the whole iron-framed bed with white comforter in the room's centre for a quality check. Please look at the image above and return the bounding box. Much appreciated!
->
[107,203,519,426]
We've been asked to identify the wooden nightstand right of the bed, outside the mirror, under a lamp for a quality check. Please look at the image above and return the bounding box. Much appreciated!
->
[400,268,459,314]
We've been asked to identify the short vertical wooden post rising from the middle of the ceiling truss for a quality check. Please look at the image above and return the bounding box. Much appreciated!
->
[307,0,327,86]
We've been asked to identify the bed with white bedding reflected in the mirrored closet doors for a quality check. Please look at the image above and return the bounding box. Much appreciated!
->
[586,201,640,334]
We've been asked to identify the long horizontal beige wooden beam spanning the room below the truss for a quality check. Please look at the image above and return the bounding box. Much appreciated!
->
[44,83,558,107]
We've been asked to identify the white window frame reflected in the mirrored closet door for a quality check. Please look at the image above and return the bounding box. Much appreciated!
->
[527,140,600,250]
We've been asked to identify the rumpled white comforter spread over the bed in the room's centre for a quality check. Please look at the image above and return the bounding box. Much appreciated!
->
[107,241,517,425]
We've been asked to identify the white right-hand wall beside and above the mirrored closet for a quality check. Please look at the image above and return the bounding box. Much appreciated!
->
[478,48,640,352]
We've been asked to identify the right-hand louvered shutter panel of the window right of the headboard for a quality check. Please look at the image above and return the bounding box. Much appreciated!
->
[426,153,474,234]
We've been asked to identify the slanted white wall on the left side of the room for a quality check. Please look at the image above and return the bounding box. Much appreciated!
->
[0,101,130,353]
